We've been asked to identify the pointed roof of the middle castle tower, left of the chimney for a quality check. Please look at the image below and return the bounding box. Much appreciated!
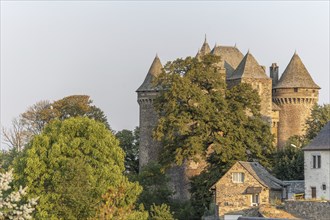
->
[229,52,268,79]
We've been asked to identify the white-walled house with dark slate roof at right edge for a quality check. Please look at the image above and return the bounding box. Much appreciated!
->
[303,122,330,200]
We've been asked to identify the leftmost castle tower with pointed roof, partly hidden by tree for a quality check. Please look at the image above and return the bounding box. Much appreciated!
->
[136,55,163,170]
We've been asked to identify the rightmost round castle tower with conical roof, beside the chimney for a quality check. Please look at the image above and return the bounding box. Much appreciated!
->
[273,53,320,147]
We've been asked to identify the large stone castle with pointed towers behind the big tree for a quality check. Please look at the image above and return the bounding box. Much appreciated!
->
[136,38,320,200]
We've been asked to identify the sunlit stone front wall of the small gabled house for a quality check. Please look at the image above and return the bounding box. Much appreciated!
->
[215,163,269,217]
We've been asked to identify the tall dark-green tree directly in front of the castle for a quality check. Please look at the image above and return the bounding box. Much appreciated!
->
[154,55,275,218]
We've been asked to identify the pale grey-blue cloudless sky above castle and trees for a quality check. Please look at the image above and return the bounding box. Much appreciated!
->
[0,0,330,143]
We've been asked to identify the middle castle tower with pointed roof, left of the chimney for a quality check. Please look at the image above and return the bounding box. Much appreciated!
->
[227,52,272,123]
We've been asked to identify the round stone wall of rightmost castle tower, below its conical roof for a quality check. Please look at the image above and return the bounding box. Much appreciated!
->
[273,88,318,147]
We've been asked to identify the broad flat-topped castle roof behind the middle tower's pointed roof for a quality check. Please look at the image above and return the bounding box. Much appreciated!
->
[211,45,243,78]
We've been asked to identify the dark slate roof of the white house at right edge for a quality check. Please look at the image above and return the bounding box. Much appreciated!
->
[303,122,330,151]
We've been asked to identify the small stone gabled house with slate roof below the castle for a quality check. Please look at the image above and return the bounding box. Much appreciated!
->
[211,161,286,219]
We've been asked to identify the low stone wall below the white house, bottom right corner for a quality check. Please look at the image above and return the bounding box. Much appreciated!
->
[284,200,330,220]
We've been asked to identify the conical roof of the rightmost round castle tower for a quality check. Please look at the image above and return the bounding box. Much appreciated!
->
[274,53,320,89]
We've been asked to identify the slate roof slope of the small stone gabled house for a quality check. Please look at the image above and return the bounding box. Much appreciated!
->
[238,161,287,190]
